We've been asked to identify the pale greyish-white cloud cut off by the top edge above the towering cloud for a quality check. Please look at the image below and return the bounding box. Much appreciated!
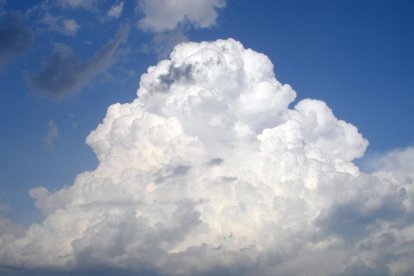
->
[138,0,226,32]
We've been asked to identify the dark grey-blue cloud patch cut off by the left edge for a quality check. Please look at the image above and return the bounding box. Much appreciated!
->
[0,14,32,67]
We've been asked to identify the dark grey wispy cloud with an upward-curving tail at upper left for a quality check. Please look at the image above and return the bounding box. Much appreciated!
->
[33,26,128,99]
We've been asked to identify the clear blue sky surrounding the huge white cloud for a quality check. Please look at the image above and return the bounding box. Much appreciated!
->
[0,0,414,229]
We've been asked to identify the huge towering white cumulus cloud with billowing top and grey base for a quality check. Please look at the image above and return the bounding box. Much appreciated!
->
[0,39,414,275]
